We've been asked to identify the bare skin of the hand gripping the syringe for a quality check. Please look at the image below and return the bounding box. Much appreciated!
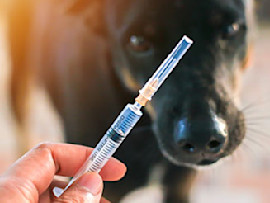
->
[0,144,126,203]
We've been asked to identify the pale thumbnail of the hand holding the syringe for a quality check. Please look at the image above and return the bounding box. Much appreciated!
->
[77,173,102,196]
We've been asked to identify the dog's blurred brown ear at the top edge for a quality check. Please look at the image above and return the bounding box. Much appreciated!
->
[67,0,106,36]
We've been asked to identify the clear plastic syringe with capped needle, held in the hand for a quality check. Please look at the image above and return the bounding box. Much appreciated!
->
[54,36,193,197]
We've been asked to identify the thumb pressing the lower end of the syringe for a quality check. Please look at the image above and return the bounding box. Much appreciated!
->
[55,172,103,203]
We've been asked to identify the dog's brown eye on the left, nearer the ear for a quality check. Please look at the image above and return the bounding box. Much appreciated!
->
[129,35,152,52]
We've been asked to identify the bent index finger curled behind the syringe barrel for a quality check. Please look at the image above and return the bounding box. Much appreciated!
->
[4,144,126,197]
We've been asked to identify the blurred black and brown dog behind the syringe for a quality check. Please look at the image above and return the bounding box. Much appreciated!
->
[7,0,253,202]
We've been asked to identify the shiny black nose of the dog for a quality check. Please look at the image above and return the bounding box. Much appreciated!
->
[175,116,227,155]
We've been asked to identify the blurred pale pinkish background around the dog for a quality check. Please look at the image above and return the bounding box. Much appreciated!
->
[0,0,270,203]
